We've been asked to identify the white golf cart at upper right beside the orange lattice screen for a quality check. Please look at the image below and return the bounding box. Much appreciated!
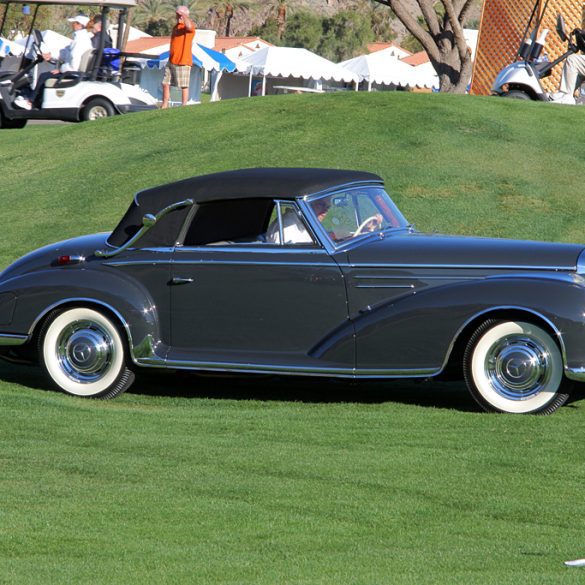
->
[492,0,585,101]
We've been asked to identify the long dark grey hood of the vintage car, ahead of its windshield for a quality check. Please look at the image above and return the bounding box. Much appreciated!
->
[348,232,585,271]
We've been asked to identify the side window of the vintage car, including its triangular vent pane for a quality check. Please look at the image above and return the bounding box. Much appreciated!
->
[183,198,314,246]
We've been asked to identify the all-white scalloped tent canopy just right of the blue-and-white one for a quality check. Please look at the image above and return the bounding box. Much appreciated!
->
[238,47,359,84]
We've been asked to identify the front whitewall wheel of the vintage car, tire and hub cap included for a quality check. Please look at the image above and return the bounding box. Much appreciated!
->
[463,319,571,414]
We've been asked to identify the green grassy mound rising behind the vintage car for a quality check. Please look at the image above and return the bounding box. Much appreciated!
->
[0,93,585,266]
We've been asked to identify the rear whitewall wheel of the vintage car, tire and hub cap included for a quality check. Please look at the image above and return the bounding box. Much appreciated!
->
[39,307,134,398]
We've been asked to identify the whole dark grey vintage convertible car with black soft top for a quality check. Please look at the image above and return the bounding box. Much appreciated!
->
[0,169,585,413]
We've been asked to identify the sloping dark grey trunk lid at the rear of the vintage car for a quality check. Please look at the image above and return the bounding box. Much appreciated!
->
[0,233,109,281]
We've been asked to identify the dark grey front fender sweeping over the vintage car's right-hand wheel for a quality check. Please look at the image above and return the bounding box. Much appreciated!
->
[354,277,585,373]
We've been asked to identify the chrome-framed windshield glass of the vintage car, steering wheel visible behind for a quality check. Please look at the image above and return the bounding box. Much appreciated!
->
[309,187,408,244]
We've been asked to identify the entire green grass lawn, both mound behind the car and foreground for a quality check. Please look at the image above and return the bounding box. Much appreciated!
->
[0,93,585,585]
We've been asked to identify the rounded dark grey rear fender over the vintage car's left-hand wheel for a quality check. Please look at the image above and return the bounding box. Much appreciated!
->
[0,268,161,361]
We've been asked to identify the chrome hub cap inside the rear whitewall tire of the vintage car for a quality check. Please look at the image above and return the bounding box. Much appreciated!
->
[57,321,114,383]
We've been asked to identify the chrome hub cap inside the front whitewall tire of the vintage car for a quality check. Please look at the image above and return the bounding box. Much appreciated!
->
[485,335,551,400]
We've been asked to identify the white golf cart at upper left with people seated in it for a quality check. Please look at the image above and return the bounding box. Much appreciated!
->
[0,0,157,128]
